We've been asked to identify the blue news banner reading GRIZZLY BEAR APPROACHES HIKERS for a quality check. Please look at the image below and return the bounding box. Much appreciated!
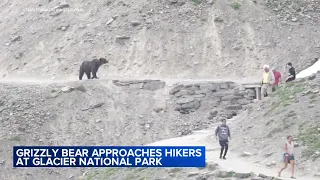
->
[13,146,206,168]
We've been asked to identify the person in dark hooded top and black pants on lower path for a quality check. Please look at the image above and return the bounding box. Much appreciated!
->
[215,119,231,159]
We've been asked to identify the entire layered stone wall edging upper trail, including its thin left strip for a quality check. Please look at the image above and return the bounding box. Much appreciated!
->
[113,80,255,120]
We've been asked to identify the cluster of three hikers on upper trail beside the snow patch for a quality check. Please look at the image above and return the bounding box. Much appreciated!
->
[261,62,296,97]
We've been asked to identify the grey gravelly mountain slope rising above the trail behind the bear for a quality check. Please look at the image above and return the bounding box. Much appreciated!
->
[0,0,320,79]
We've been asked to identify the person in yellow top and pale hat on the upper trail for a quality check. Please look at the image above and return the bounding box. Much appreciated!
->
[261,65,274,97]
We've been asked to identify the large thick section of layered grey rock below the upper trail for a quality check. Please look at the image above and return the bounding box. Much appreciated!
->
[169,82,253,114]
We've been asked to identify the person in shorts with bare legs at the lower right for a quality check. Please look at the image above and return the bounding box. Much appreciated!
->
[278,136,296,179]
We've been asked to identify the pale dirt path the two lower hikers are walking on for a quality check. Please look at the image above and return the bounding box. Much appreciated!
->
[149,124,319,180]
